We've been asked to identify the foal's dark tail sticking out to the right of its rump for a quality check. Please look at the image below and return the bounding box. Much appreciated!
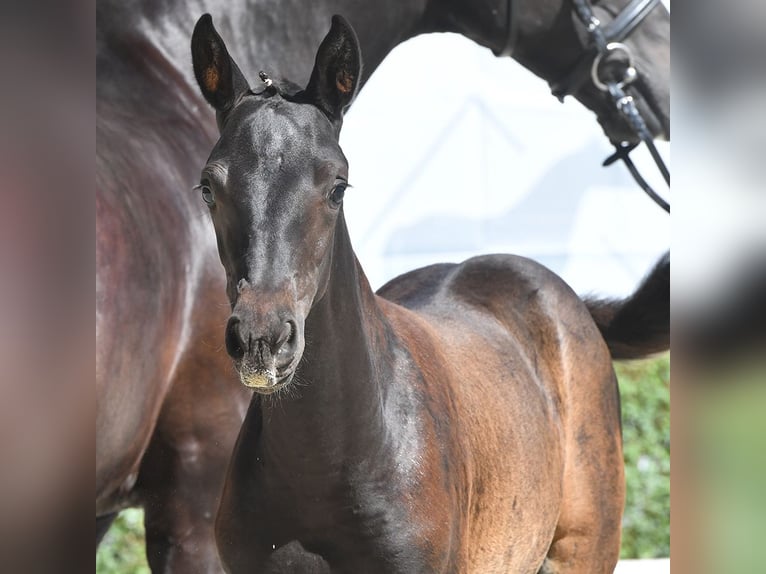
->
[585,252,670,359]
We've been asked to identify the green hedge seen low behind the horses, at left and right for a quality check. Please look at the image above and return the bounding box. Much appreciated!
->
[96,357,670,574]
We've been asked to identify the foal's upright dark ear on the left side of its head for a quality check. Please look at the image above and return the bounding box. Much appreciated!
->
[192,14,250,112]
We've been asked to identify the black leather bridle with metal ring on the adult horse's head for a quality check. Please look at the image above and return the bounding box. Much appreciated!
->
[495,0,670,213]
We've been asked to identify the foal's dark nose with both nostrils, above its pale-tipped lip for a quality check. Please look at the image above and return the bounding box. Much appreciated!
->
[226,314,297,370]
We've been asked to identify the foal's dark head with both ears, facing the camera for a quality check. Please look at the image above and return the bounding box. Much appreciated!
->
[192,15,361,393]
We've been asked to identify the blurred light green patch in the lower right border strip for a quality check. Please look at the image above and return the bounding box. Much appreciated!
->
[688,364,766,574]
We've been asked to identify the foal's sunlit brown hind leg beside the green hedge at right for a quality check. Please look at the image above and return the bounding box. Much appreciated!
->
[539,368,625,574]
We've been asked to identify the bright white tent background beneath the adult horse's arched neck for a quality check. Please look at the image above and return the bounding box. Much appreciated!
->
[341,34,670,296]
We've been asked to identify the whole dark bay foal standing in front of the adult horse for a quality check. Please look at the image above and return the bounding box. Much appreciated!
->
[192,16,668,574]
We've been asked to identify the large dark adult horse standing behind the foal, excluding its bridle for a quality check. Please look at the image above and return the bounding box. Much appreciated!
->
[96,0,669,571]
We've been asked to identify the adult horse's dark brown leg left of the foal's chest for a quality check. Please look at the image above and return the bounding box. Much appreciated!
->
[136,304,250,573]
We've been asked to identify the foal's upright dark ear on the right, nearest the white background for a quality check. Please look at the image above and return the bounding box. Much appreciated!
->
[306,14,362,122]
